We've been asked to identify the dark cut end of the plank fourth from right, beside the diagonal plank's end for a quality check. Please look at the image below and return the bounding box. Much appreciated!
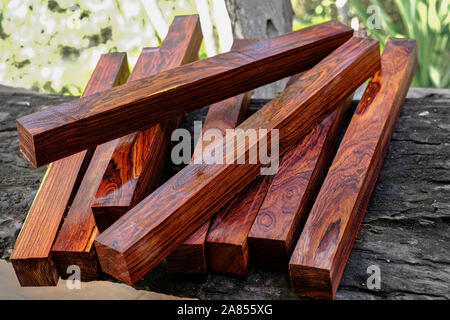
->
[166,242,207,273]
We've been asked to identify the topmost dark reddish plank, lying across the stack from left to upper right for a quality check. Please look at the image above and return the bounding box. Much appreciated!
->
[17,21,353,166]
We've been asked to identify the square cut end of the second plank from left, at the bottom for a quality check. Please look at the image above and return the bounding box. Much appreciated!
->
[52,248,98,281]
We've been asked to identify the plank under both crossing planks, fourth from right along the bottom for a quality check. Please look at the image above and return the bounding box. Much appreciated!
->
[166,39,258,273]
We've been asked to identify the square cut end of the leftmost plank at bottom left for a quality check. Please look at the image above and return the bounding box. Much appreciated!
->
[10,257,59,287]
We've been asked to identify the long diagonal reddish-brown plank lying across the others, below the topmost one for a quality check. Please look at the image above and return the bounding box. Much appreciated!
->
[96,38,380,283]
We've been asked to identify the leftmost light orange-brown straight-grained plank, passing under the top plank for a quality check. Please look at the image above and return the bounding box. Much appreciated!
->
[10,53,129,286]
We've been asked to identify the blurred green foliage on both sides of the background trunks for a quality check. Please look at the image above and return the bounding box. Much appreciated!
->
[0,0,450,95]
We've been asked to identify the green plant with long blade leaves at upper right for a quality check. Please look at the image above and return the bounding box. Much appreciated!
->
[350,0,450,88]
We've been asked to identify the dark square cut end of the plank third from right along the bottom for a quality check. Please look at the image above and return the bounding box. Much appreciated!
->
[206,242,249,275]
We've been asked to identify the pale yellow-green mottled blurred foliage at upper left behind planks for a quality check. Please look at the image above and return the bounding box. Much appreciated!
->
[0,0,199,95]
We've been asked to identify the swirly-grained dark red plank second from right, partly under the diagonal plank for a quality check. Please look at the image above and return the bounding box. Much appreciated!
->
[248,95,352,271]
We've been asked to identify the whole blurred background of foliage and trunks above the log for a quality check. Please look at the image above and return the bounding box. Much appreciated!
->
[0,0,450,97]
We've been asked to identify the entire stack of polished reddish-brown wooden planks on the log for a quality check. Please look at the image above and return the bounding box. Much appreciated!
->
[11,15,417,298]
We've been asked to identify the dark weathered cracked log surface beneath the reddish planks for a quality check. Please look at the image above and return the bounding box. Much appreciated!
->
[0,85,450,299]
